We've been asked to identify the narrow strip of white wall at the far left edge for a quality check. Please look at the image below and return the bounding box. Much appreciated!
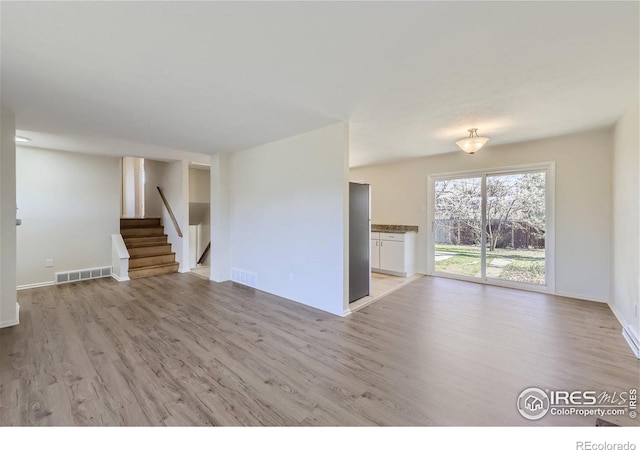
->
[0,111,19,328]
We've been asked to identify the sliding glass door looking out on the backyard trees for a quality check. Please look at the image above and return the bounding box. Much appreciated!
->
[429,164,553,290]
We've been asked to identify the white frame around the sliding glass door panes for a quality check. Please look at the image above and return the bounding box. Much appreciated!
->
[426,161,556,294]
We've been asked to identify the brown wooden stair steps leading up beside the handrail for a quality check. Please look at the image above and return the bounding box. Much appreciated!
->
[120,218,178,279]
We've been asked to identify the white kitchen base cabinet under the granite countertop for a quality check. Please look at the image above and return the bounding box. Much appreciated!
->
[371,232,416,277]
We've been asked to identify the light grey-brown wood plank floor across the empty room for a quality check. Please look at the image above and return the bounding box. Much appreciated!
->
[0,274,640,426]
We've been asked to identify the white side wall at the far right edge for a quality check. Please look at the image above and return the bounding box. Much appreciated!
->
[610,98,640,336]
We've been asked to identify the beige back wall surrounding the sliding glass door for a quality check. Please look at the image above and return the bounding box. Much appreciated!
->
[350,130,612,302]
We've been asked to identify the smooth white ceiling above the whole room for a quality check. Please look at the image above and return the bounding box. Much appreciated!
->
[0,1,639,166]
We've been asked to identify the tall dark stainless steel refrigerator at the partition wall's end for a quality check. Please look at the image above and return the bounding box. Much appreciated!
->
[349,183,371,303]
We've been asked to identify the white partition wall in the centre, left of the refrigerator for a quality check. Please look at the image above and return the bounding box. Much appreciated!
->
[219,123,349,315]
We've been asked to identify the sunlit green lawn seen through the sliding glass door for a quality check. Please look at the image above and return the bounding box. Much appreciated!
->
[436,244,545,284]
